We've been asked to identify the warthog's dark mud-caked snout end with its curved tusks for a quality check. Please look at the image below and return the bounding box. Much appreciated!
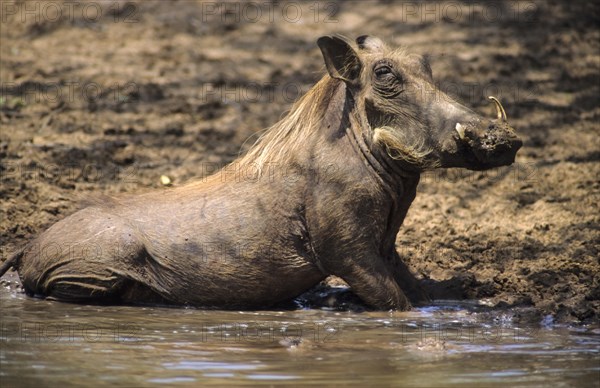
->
[455,97,523,170]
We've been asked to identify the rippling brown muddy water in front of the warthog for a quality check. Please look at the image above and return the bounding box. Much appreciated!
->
[0,276,600,388]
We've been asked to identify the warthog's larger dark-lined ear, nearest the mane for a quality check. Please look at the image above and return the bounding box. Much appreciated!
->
[317,36,362,83]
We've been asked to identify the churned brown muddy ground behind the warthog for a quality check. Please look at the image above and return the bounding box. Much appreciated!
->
[0,1,600,322]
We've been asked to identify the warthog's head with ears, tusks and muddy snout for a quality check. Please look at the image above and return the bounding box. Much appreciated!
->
[317,36,522,170]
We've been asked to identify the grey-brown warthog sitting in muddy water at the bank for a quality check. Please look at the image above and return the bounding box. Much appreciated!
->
[0,36,522,309]
